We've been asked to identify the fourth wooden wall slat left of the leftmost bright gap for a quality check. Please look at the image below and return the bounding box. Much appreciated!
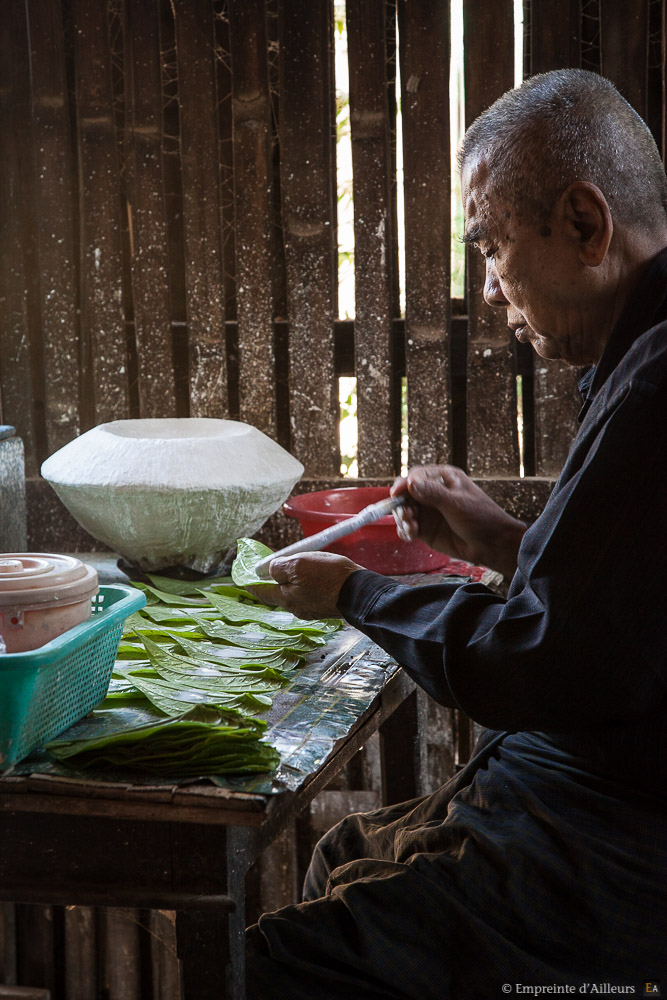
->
[125,0,176,417]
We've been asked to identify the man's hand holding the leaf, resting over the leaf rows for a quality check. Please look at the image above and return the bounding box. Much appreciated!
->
[248,552,363,620]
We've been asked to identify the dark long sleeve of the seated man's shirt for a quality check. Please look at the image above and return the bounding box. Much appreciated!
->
[339,372,667,732]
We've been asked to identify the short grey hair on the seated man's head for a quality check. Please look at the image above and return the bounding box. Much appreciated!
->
[459,69,667,228]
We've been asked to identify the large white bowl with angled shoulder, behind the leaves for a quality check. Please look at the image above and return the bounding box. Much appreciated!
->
[41,417,303,573]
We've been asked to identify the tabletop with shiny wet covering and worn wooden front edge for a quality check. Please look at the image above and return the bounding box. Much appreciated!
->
[0,625,414,827]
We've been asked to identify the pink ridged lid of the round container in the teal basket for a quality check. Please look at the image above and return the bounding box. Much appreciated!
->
[0,552,97,607]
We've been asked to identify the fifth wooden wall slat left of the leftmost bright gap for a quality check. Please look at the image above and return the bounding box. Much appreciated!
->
[73,0,128,427]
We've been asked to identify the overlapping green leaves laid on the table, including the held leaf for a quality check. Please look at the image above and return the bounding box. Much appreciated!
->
[48,539,341,776]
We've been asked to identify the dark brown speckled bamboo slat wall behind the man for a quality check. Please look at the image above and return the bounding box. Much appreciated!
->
[0,0,667,1000]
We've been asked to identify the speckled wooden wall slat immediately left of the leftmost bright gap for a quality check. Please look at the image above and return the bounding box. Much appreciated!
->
[279,0,339,476]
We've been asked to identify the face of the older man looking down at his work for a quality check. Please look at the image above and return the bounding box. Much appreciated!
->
[462,158,603,365]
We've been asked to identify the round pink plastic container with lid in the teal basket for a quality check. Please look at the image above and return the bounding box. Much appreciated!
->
[0,552,98,653]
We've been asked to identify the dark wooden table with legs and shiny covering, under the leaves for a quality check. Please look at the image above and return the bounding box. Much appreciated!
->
[0,626,418,1000]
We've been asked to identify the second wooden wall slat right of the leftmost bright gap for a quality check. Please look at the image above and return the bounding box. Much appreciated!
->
[398,0,452,464]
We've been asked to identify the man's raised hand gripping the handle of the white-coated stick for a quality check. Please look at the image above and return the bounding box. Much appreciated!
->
[391,465,526,580]
